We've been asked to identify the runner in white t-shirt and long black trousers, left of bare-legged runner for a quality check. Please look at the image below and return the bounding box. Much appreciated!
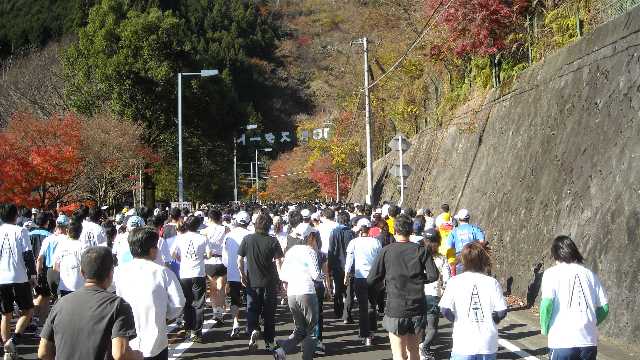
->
[172,216,208,342]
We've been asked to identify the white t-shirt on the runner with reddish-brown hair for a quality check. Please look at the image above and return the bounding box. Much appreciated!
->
[440,272,507,355]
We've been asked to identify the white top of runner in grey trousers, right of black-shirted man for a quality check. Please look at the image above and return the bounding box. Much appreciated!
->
[280,245,321,296]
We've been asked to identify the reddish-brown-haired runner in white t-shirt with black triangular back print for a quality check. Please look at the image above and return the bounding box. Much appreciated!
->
[440,242,507,360]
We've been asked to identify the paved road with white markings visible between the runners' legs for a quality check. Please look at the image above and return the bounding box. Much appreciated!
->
[10,303,640,360]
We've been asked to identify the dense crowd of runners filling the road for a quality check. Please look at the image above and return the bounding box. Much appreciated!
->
[0,203,609,360]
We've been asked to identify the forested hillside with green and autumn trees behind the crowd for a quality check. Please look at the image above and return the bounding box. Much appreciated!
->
[0,0,636,207]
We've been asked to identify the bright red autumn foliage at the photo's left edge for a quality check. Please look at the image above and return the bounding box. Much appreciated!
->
[0,113,81,208]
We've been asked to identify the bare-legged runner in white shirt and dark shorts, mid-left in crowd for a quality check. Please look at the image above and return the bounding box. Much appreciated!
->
[200,209,228,326]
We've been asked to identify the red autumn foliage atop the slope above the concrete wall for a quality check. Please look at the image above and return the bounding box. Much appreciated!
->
[425,0,530,56]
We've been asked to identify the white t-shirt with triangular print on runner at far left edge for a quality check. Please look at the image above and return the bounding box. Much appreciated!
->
[0,224,31,284]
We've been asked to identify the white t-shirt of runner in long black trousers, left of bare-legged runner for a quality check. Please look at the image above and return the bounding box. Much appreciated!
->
[172,231,207,279]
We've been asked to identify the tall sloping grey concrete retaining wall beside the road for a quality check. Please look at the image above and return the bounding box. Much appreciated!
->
[350,9,640,343]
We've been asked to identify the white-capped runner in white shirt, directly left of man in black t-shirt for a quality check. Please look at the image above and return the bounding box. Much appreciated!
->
[222,211,251,337]
